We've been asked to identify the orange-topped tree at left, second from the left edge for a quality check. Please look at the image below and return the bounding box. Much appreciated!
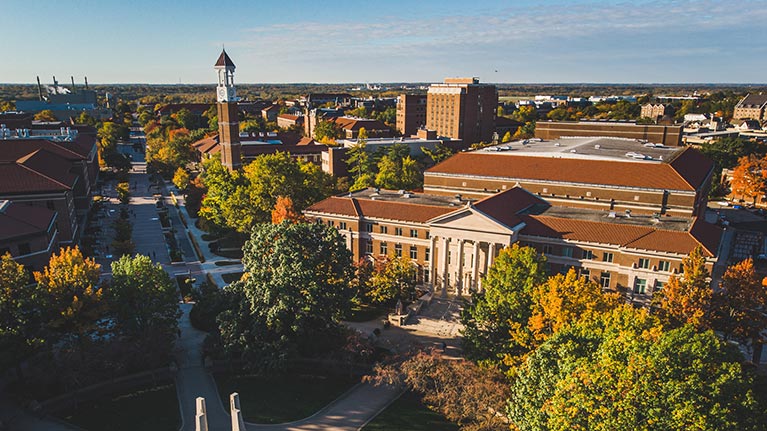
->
[34,247,104,338]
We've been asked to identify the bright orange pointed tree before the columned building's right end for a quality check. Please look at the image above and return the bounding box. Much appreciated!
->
[653,247,713,329]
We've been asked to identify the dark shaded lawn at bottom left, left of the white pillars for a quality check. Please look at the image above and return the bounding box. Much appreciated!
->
[59,384,181,431]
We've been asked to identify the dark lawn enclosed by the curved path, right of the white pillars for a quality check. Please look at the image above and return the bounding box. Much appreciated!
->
[216,374,359,424]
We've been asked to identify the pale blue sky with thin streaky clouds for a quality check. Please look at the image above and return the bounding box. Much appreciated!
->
[0,0,767,83]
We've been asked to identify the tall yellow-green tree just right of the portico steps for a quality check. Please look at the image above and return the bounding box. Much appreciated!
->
[461,244,547,363]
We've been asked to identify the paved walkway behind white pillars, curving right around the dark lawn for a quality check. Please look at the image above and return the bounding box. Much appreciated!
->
[176,304,402,431]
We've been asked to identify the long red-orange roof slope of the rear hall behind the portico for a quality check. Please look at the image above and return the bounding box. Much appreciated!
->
[426,149,712,191]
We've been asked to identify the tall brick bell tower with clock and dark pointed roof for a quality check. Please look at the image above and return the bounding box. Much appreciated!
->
[213,50,242,171]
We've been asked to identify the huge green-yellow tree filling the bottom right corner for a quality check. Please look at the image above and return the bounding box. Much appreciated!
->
[507,305,763,431]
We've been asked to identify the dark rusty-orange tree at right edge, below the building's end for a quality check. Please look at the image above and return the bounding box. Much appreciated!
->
[714,258,767,362]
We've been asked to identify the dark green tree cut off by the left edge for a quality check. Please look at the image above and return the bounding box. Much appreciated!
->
[0,253,45,376]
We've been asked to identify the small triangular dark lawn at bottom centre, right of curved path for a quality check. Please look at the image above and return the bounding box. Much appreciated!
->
[362,392,458,431]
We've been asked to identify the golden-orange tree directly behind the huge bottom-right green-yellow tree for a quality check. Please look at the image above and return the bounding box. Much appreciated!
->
[528,268,620,341]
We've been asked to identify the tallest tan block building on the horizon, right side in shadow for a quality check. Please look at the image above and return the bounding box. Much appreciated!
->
[426,78,498,144]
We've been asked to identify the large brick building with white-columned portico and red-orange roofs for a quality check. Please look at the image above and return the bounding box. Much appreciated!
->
[305,138,722,301]
